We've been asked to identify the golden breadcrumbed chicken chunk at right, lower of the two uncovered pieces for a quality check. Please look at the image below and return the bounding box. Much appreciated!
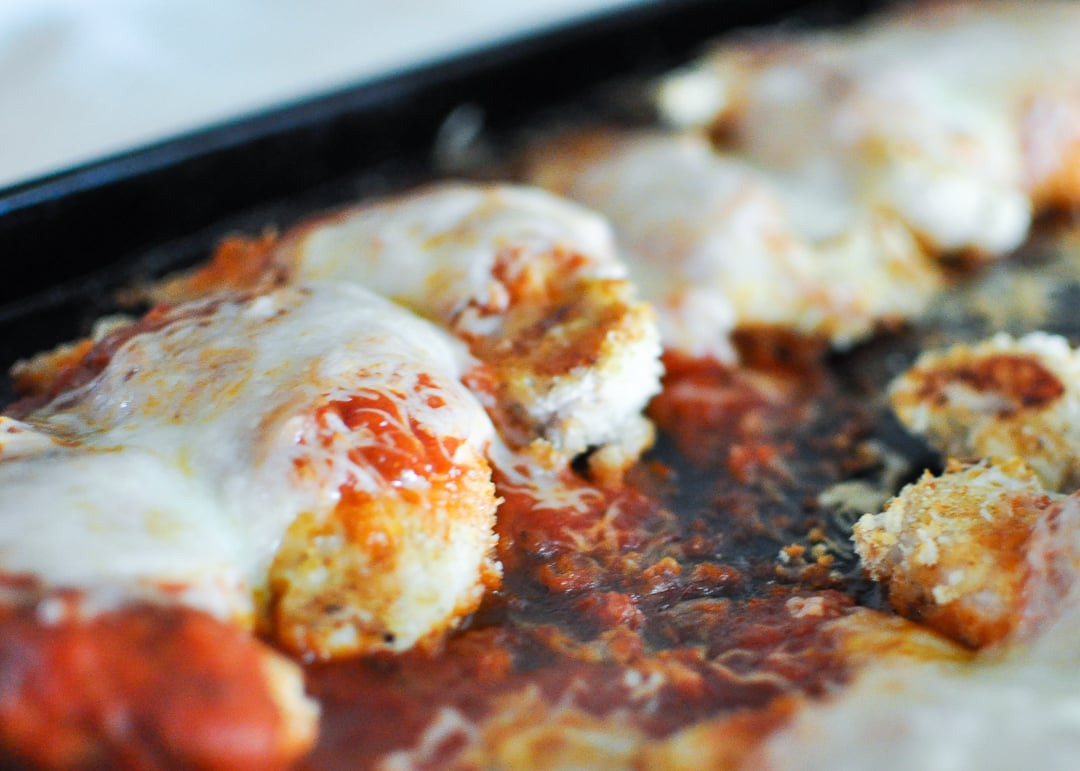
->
[854,458,1075,648]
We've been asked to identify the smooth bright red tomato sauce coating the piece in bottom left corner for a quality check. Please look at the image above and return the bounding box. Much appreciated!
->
[0,605,300,770]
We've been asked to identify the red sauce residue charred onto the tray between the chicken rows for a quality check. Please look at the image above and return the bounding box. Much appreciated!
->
[306,343,885,769]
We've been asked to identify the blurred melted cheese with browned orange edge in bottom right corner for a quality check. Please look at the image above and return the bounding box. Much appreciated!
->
[764,587,1080,771]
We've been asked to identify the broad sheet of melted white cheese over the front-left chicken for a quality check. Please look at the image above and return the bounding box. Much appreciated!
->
[0,285,495,639]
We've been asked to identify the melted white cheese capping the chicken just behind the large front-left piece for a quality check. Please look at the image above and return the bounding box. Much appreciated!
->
[282,184,626,335]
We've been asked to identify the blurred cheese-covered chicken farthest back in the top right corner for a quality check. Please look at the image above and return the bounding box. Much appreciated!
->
[659,1,1080,256]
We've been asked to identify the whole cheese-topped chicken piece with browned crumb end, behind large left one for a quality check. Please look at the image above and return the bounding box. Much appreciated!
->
[152,184,661,470]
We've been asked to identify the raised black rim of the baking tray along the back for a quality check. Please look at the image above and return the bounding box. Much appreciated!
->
[0,0,877,397]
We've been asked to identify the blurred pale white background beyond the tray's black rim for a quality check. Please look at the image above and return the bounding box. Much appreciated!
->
[0,0,644,188]
